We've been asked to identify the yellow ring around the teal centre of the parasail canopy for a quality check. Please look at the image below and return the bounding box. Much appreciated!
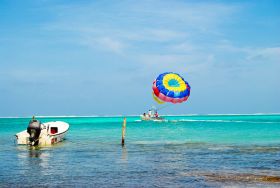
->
[162,73,187,92]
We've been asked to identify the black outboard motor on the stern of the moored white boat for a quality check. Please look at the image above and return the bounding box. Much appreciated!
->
[27,117,41,146]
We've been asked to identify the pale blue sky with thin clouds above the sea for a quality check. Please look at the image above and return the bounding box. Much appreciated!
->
[0,0,280,116]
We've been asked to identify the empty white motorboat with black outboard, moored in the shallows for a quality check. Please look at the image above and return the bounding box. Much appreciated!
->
[15,118,69,146]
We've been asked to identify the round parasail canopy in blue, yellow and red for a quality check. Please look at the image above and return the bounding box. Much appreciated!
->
[153,72,191,104]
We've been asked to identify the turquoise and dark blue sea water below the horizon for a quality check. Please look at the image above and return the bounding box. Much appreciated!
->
[0,115,280,187]
